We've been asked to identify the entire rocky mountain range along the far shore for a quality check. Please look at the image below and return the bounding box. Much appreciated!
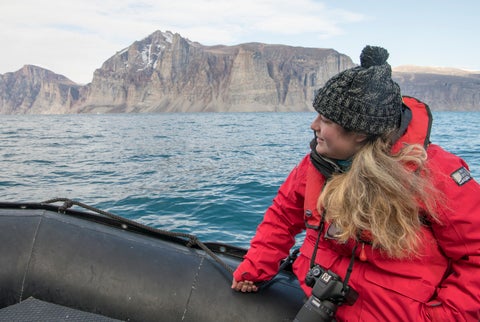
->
[0,31,480,114]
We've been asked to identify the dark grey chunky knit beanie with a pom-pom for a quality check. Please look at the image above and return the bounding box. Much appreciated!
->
[313,46,402,135]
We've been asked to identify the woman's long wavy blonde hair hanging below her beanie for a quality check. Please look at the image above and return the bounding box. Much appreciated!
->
[318,136,438,258]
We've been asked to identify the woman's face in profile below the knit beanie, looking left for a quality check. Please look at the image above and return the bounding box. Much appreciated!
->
[310,114,367,160]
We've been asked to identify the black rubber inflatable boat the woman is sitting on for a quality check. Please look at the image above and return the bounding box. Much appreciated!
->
[0,200,304,322]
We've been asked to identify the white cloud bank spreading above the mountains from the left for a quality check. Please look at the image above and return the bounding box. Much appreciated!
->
[0,0,364,83]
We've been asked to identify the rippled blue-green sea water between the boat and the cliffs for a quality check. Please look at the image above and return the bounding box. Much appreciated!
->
[0,112,480,247]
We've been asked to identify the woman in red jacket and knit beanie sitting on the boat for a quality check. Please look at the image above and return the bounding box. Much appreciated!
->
[232,46,480,321]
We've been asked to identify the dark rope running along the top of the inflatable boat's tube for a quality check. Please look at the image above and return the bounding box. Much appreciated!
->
[41,198,233,274]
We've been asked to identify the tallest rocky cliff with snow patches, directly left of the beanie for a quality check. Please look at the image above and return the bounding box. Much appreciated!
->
[77,31,353,112]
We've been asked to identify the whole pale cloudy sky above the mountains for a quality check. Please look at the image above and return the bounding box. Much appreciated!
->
[0,0,480,84]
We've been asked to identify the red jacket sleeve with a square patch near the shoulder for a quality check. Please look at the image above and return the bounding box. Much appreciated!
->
[429,146,480,321]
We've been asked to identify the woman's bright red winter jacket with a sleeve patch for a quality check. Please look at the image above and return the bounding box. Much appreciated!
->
[234,98,480,321]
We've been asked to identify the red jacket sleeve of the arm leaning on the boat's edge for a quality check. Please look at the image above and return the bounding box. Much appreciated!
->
[233,156,310,282]
